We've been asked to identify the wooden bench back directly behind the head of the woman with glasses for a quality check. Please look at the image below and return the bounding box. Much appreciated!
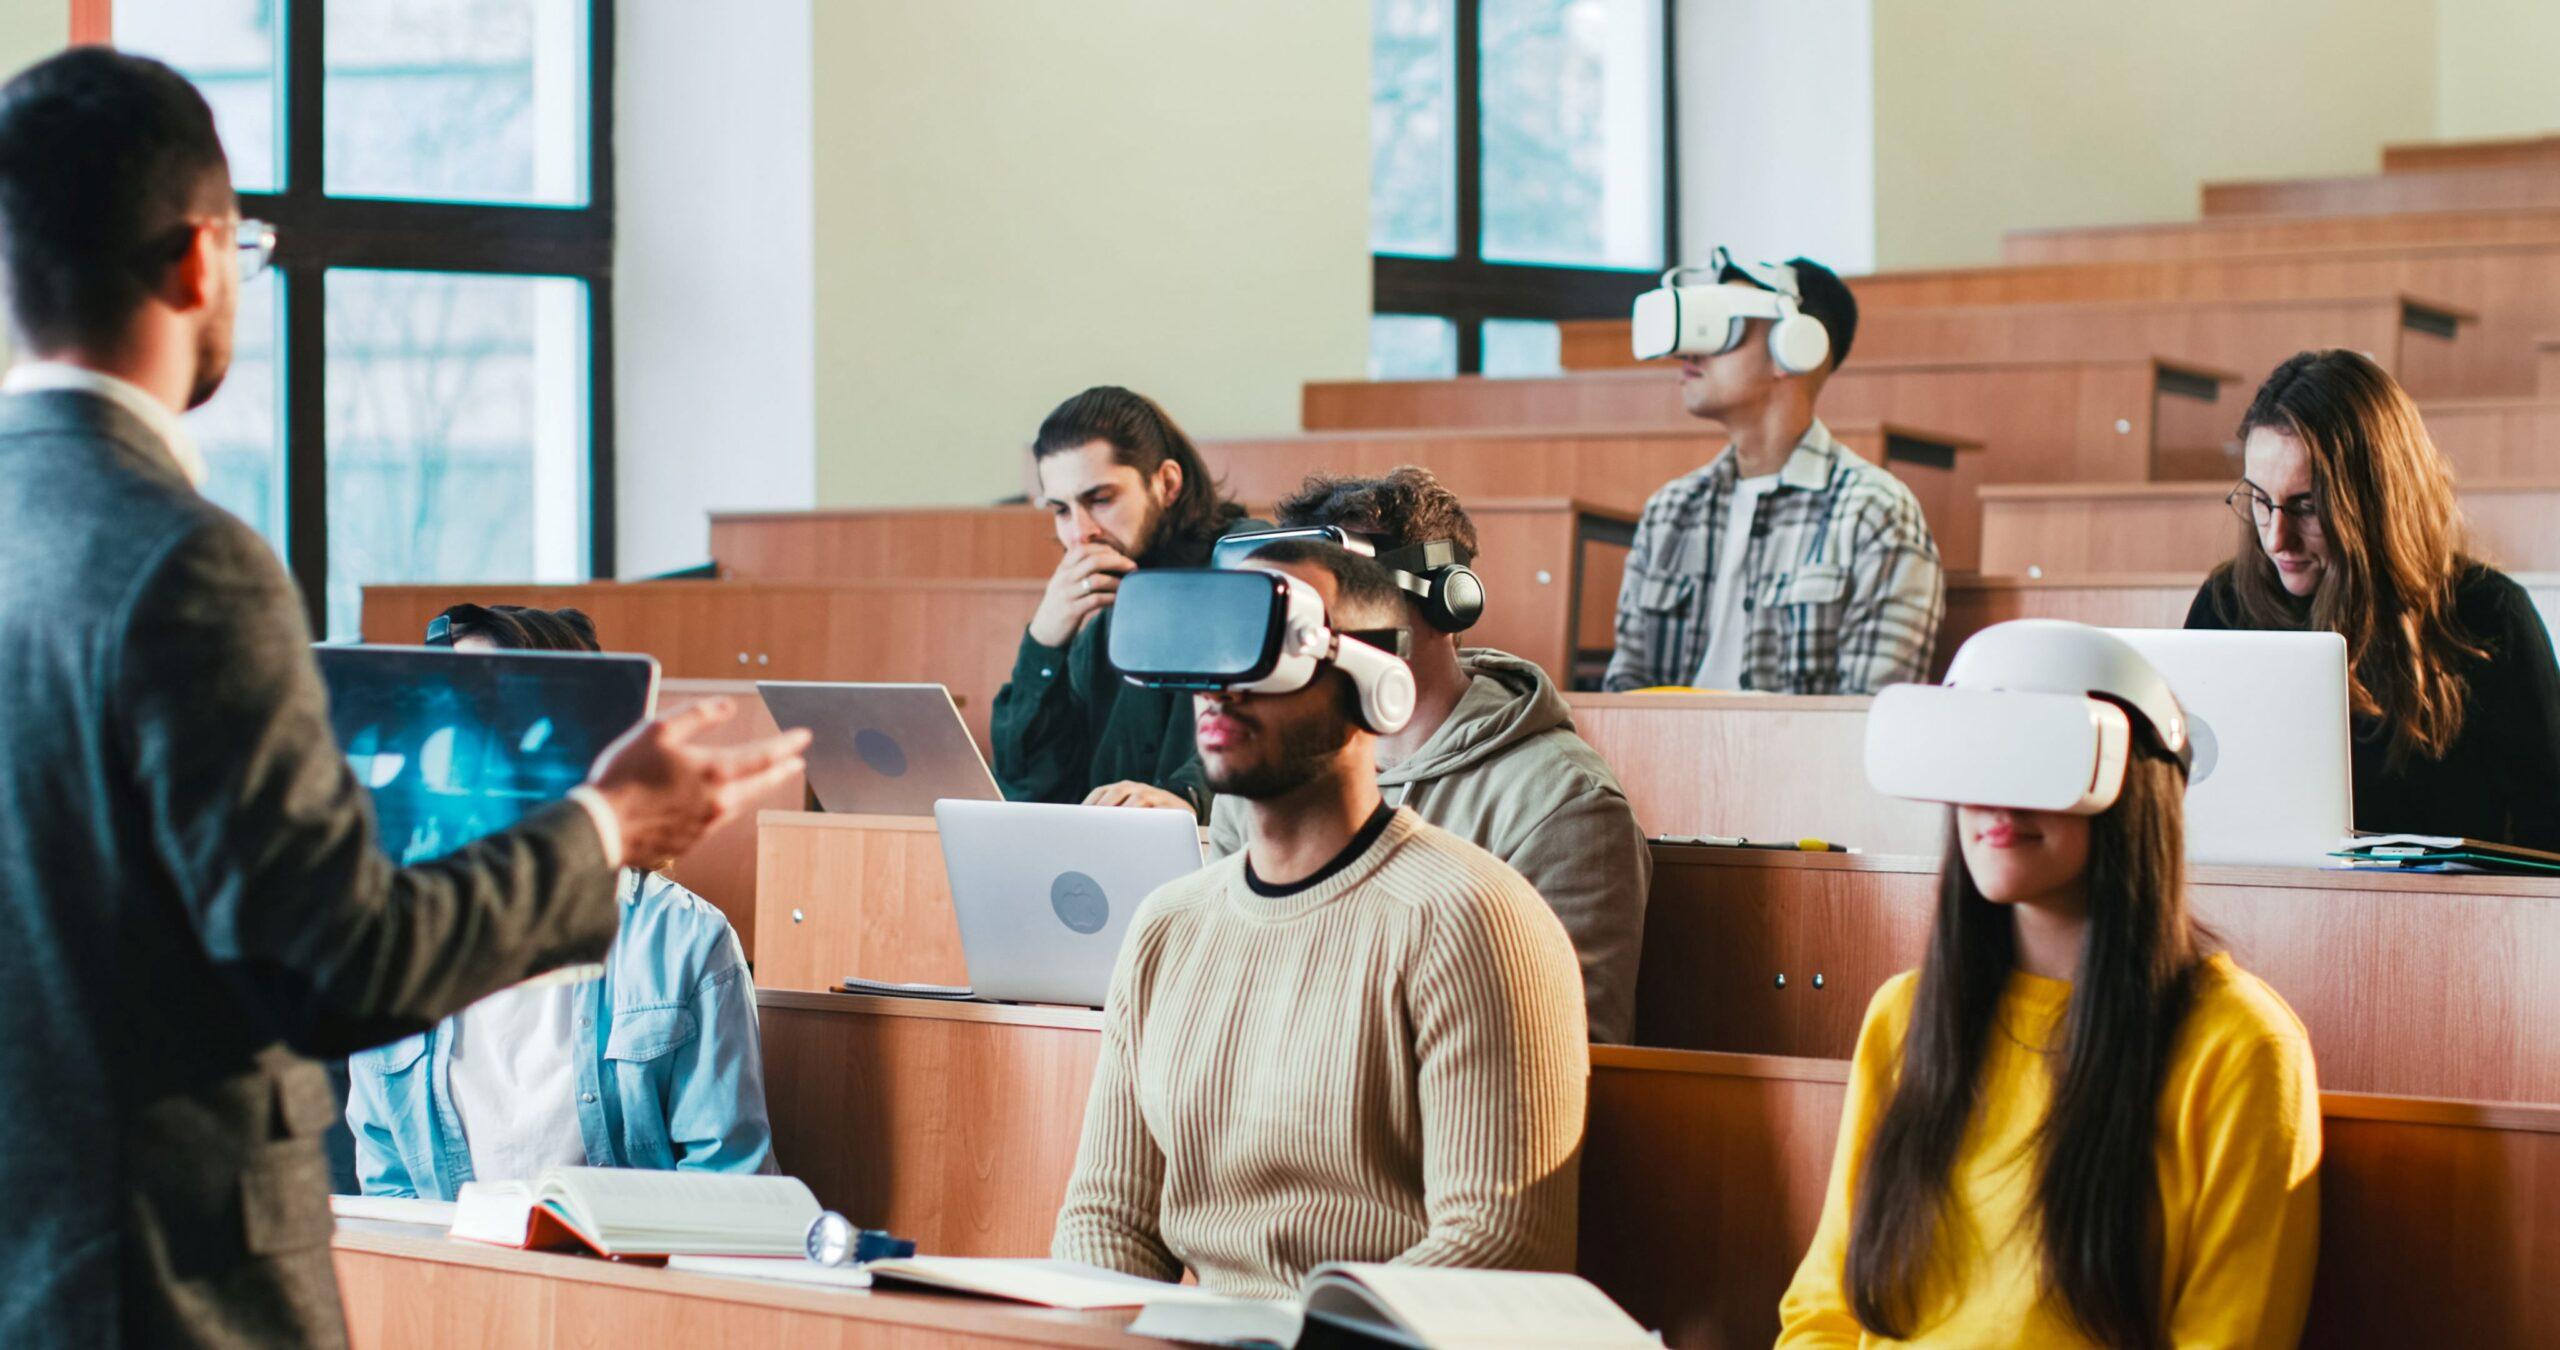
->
[1981,482,2560,576]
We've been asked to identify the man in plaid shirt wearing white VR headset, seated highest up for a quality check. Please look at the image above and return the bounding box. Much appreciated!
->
[1603,248,1946,694]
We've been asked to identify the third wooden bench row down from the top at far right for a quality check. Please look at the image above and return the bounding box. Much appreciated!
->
[1999,210,2560,264]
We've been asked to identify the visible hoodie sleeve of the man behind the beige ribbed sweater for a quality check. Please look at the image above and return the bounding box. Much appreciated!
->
[1510,786,1654,1043]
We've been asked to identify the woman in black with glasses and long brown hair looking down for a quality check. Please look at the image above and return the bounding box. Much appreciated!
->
[2186,351,2560,850]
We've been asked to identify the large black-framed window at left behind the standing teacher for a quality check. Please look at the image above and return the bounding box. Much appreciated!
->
[113,0,612,638]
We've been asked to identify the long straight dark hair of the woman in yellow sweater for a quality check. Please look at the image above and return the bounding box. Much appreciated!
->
[1848,735,2212,1350]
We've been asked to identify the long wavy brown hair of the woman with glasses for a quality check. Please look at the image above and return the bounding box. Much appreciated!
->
[2220,351,2488,766]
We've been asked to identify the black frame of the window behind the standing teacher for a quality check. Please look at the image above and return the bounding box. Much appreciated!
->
[96,0,614,635]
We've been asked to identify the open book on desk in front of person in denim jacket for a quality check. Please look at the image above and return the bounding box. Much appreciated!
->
[453,1168,819,1260]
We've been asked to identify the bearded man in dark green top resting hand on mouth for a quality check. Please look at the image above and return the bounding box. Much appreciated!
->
[991,387,1252,815]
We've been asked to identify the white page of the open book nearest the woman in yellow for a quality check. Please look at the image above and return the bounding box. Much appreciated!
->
[1306,1265,1661,1347]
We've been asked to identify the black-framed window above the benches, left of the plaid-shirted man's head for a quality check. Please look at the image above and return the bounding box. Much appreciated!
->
[1370,0,1677,379]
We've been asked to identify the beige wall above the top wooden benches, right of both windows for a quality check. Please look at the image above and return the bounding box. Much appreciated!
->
[1874,0,2426,266]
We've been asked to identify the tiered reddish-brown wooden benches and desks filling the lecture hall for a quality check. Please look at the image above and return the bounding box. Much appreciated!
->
[340,138,2560,1347]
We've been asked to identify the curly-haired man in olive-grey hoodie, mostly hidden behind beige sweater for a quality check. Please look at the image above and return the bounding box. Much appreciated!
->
[1208,466,1654,1040]
